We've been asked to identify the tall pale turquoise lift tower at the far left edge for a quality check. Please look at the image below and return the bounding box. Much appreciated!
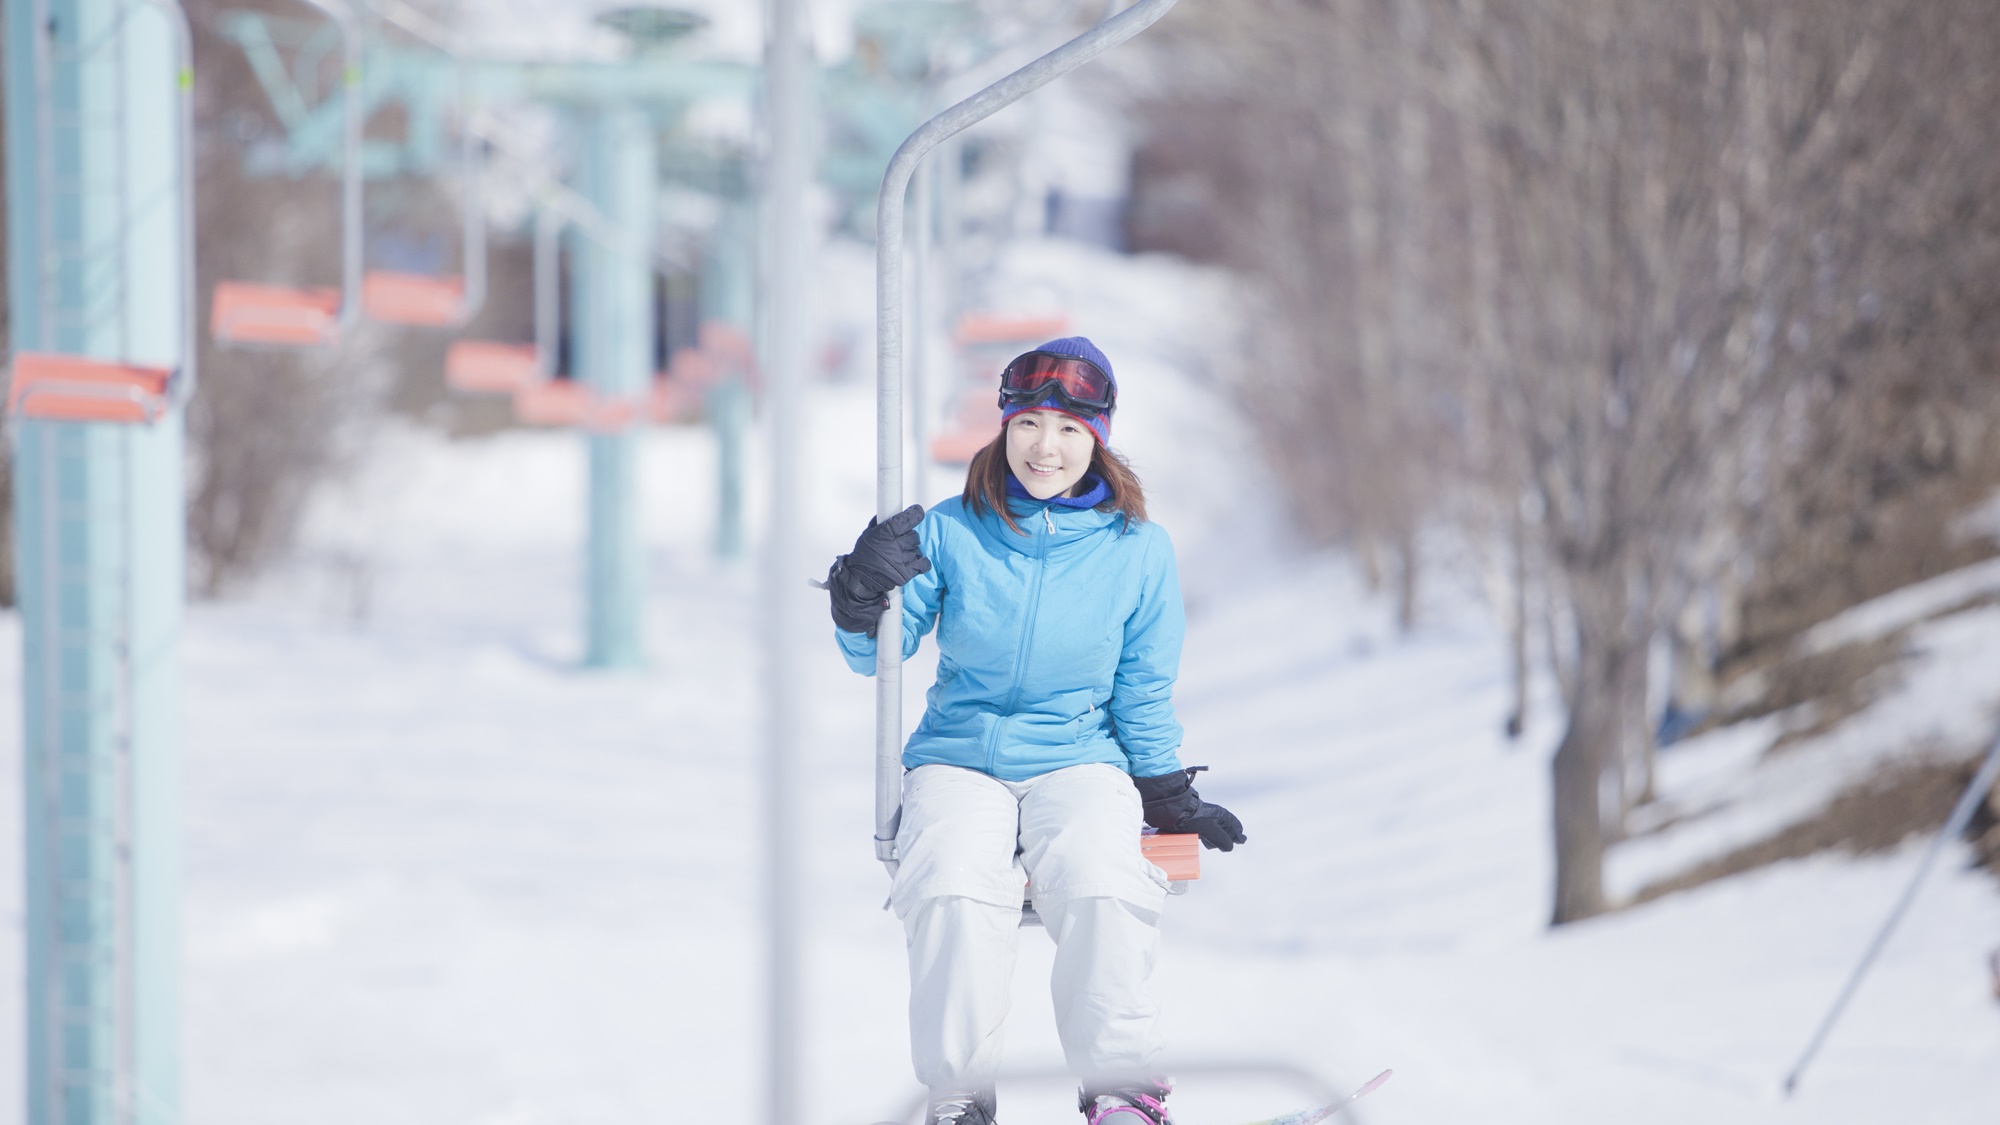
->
[0,0,194,1125]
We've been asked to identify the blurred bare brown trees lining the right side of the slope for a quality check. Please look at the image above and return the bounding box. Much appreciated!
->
[1132,0,2000,923]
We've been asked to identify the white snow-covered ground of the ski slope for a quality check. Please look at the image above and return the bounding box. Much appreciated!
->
[0,244,2000,1125]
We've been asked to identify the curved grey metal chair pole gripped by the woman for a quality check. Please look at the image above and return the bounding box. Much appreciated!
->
[874,0,1176,873]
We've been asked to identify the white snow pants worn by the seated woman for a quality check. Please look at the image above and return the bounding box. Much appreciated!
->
[890,763,1166,1091]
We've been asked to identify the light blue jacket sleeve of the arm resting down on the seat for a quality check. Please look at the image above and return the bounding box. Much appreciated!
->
[1110,524,1188,777]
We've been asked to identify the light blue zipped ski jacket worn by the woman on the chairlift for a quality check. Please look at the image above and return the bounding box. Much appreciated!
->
[834,496,1186,781]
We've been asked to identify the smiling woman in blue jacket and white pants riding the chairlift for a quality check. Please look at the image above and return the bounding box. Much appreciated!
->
[826,336,1244,1125]
